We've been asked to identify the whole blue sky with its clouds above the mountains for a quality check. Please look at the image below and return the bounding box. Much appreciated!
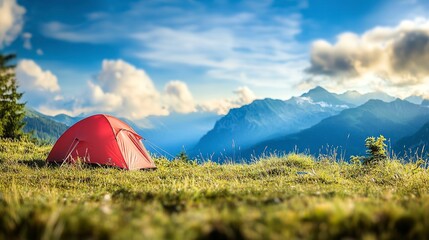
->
[0,0,429,120]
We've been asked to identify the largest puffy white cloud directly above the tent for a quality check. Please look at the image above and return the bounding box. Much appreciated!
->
[88,60,168,119]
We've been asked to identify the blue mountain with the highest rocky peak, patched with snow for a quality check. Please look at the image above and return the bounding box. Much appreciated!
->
[191,87,351,157]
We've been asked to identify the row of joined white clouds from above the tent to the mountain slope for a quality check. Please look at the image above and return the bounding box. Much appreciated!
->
[85,60,255,120]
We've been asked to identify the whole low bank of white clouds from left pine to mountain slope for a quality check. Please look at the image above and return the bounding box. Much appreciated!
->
[16,59,255,118]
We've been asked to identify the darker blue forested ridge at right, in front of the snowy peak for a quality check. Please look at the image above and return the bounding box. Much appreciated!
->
[247,99,429,159]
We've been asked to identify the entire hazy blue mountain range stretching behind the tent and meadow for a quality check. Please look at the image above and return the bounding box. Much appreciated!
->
[24,87,429,161]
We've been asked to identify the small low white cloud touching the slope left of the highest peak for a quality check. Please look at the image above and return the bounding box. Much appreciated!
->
[199,86,256,115]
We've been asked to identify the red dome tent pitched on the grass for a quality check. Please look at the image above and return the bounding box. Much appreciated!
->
[47,114,156,170]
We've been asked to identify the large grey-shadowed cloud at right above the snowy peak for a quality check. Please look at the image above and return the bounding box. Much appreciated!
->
[306,18,429,95]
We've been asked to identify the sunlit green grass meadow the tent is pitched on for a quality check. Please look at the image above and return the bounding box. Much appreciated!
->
[0,140,429,239]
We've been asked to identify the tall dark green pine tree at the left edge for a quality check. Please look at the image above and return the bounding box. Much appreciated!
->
[0,54,25,139]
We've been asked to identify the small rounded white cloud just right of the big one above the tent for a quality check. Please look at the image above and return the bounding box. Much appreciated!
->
[165,80,196,113]
